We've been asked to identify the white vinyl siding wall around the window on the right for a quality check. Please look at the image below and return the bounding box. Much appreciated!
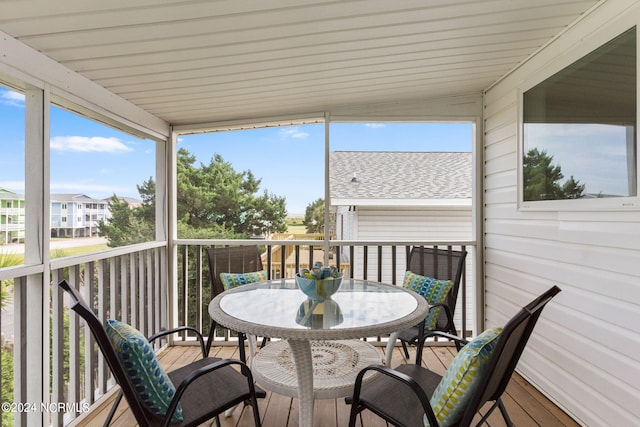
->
[483,1,640,426]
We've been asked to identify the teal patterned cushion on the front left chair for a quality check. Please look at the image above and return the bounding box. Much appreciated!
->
[105,320,183,422]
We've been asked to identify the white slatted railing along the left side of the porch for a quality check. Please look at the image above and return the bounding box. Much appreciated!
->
[0,242,168,426]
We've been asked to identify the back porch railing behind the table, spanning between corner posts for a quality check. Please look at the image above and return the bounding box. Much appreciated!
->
[176,240,475,344]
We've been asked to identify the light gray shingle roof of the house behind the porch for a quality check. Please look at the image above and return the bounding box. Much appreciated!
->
[329,151,472,200]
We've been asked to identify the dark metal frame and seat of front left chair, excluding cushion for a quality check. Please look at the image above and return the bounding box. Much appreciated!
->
[59,280,264,427]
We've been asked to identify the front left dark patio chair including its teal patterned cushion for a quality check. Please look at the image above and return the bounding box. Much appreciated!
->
[59,280,264,427]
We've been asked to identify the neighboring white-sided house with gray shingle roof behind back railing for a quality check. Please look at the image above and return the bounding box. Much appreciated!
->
[329,151,475,332]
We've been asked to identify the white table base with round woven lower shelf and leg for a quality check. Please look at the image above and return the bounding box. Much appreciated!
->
[251,340,382,426]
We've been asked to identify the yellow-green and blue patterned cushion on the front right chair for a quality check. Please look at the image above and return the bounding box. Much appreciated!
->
[424,328,502,427]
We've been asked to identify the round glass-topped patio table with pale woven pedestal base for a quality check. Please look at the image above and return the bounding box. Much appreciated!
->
[209,279,429,426]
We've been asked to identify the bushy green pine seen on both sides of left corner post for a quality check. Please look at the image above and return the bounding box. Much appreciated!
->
[99,149,287,247]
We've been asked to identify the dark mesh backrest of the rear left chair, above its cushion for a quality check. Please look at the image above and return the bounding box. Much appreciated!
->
[206,245,262,298]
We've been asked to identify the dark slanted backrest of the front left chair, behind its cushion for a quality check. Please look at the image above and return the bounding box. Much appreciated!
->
[58,280,152,426]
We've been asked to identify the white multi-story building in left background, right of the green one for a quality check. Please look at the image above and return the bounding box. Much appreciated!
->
[51,194,109,237]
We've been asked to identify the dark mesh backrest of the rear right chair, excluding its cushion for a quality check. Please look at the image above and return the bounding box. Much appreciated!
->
[407,246,467,331]
